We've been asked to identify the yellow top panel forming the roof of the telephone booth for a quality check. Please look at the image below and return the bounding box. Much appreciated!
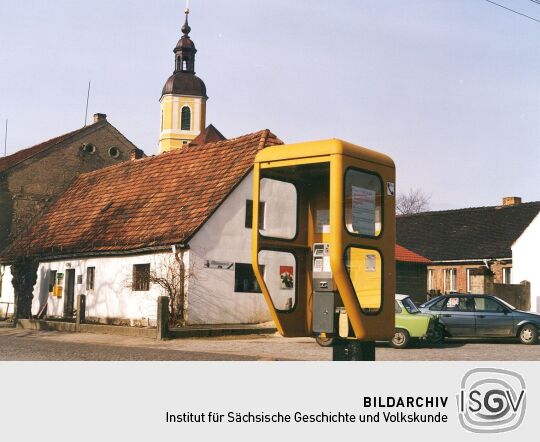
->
[255,138,395,168]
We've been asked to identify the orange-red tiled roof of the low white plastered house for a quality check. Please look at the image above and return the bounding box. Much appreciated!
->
[2,130,283,260]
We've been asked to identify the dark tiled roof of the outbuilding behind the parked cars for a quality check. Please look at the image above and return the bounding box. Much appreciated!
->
[396,201,540,261]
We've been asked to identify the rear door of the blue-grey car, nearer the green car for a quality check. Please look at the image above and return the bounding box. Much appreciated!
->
[439,296,476,336]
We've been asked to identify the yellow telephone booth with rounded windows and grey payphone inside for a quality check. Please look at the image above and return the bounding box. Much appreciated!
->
[252,139,395,360]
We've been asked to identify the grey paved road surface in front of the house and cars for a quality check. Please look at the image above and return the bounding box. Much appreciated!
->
[0,329,540,361]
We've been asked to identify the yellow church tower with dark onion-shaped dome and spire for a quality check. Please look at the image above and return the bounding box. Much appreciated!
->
[159,4,208,153]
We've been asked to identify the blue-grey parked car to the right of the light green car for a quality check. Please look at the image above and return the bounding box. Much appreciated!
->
[420,293,540,344]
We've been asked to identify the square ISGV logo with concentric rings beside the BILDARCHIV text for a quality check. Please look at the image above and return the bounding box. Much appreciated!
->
[457,368,527,433]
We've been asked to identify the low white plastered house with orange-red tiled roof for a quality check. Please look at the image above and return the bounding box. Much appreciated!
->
[0,130,296,324]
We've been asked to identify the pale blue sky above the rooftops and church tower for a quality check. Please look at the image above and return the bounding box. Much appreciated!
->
[0,0,540,210]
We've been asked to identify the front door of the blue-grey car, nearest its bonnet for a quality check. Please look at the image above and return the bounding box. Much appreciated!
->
[474,296,514,337]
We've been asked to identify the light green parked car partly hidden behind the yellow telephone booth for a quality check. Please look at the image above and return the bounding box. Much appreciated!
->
[316,295,444,348]
